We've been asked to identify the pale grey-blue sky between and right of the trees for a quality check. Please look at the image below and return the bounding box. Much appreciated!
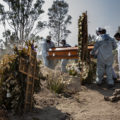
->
[0,0,120,46]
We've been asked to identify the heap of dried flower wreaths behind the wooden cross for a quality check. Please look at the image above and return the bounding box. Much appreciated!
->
[0,41,40,113]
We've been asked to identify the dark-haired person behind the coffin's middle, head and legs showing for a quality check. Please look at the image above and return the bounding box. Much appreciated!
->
[61,40,71,73]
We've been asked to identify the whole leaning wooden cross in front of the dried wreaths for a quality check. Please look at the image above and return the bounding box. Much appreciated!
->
[17,48,39,112]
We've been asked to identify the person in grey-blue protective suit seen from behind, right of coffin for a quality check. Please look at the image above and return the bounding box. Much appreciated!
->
[91,30,117,88]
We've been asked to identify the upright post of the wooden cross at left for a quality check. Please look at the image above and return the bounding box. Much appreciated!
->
[25,50,37,112]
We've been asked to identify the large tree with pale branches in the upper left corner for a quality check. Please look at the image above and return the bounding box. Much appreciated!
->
[0,0,45,44]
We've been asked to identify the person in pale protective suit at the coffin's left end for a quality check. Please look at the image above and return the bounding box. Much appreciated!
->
[41,36,55,69]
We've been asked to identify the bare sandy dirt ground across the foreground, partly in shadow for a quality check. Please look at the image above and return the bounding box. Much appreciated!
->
[9,79,120,120]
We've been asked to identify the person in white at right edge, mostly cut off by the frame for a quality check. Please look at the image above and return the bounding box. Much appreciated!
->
[114,33,120,78]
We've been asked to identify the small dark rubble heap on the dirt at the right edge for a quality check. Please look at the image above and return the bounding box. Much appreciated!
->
[104,89,120,102]
